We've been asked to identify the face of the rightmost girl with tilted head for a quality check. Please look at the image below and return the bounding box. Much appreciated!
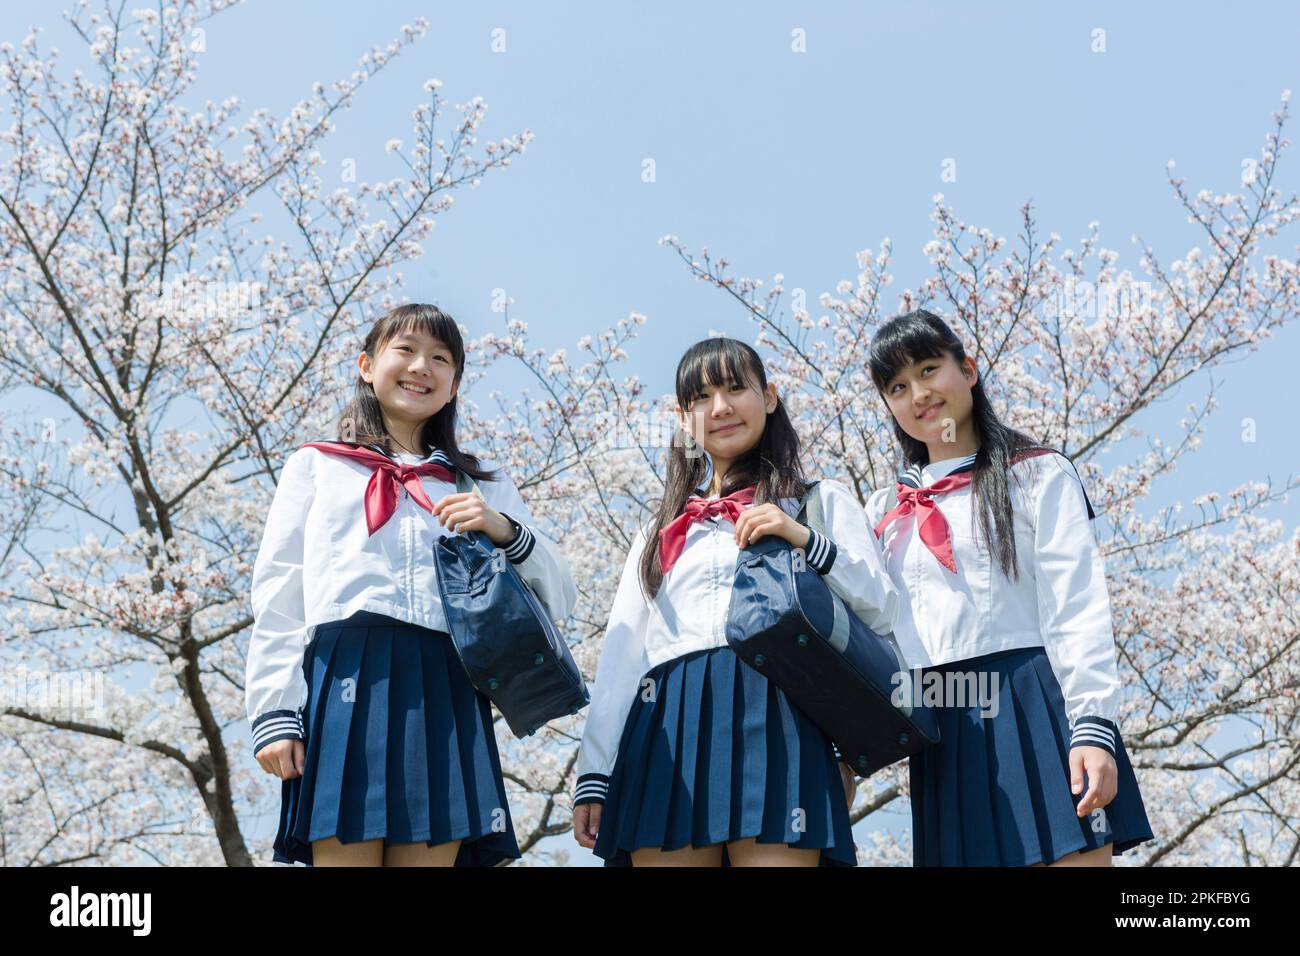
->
[885,352,979,460]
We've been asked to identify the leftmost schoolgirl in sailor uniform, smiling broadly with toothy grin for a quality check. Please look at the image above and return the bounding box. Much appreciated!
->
[246,304,577,866]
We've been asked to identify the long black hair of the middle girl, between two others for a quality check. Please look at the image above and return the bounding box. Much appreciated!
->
[641,338,809,597]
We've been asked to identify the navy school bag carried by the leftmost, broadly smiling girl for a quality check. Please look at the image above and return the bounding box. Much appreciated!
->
[433,470,590,737]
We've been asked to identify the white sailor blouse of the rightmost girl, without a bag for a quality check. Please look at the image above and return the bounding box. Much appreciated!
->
[867,451,1121,754]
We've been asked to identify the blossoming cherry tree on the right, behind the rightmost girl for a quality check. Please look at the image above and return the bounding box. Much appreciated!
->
[650,91,1300,866]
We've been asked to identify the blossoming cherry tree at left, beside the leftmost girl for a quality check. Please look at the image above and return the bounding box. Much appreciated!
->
[0,0,532,865]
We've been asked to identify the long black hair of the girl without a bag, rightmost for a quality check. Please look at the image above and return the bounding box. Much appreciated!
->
[870,308,1045,579]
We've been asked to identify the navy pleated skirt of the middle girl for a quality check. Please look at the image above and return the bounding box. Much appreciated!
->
[594,648,857,866]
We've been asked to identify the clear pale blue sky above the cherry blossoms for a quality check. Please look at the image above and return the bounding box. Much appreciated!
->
[0,0,1300,868]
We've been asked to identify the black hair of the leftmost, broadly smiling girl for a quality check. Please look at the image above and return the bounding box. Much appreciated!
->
[338,303,499,481]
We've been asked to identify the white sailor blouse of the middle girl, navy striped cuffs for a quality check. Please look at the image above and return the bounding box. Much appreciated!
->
[573,479,900,806]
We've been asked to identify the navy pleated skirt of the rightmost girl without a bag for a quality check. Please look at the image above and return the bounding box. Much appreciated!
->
[909,646,1152,866]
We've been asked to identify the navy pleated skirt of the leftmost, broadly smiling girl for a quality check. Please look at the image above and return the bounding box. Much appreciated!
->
[274,611,520,866]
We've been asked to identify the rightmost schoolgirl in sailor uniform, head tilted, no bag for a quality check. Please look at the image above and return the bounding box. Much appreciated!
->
[867,310,1152,866]
